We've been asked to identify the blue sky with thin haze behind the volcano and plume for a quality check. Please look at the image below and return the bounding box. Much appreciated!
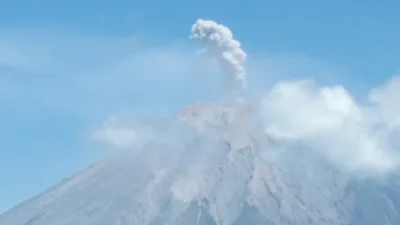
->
[0,0,400,212]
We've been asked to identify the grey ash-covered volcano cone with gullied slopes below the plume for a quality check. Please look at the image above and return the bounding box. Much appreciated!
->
[0,103,400,225]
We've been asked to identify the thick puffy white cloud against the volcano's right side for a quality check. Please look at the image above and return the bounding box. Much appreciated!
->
[261,78,400,174]
